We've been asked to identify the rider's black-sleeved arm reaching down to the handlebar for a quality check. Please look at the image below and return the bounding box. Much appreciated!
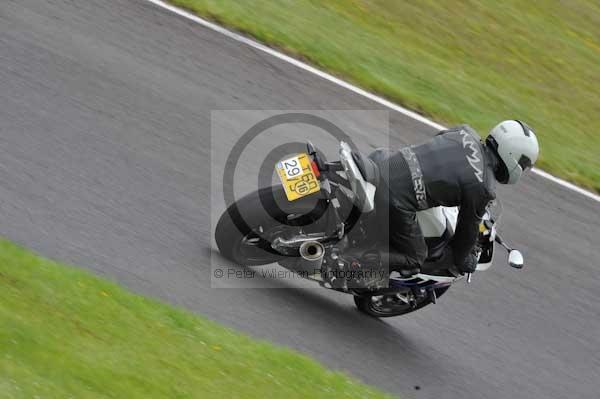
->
[452,186,494,265]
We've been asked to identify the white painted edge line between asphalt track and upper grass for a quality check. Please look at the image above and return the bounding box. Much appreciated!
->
[146,0,600,202]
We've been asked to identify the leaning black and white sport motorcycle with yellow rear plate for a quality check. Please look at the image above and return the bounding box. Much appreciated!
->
[215,142,524,317]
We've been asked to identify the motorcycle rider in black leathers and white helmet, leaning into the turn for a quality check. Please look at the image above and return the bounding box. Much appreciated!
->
[369,120,539,277]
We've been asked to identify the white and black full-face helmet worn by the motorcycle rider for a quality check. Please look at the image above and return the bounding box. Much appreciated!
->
[485,120,540,184]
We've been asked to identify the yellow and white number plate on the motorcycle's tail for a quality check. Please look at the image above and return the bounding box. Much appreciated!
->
[276,154,320,201]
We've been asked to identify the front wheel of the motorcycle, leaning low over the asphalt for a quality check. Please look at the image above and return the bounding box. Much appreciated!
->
[354,287,450,317]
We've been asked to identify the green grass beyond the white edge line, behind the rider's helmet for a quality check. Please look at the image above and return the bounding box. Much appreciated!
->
[171,0,600,192]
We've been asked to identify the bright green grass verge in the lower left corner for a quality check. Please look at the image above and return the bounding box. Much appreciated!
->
[0,239,394,399]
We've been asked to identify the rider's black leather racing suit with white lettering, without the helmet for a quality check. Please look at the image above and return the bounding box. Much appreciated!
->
[369,125,496,270]
